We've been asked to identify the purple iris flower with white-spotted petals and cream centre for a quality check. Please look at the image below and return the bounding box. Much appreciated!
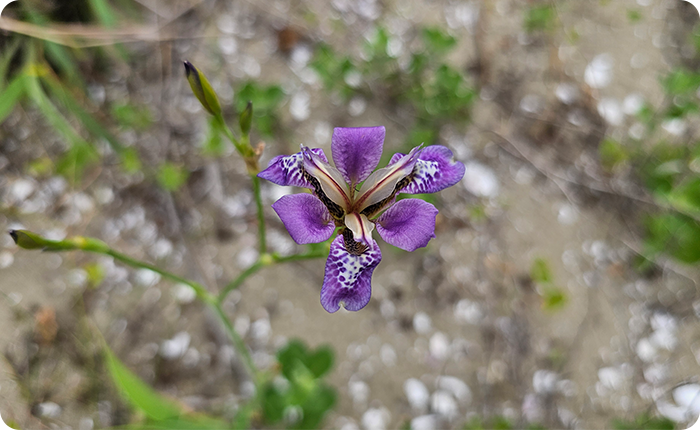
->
[258,127,464,312]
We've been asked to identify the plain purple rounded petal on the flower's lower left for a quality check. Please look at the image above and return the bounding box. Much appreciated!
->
[272,194,335,245]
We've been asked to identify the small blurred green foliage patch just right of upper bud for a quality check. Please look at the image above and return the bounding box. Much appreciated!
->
[236,81,285,136]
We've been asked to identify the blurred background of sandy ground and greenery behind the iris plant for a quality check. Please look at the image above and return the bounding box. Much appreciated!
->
[0,0,700,430]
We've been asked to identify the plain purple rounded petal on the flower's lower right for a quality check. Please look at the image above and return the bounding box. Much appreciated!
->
[377,199,438,251]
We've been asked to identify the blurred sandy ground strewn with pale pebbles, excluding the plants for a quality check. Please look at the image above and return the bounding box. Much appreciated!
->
[0,0,700,430]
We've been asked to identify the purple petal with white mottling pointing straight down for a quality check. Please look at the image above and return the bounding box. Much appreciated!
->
[321,235,382,313]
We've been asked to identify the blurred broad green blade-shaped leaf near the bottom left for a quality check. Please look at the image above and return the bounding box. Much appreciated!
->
[104,345,182,421]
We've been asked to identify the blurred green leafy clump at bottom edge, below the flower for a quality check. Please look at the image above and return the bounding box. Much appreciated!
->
[263,341,336,429]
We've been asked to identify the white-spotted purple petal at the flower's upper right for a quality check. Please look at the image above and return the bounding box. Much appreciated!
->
[389,145,464,194]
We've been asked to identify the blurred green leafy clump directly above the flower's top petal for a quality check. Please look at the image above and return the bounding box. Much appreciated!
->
[311,27,475,147]
